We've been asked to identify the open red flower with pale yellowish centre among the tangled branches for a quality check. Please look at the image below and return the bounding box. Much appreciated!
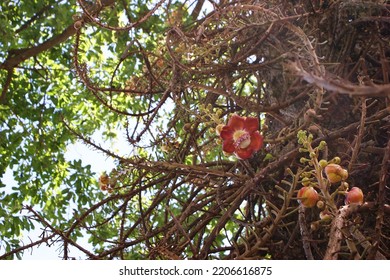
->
[220,114,263,159]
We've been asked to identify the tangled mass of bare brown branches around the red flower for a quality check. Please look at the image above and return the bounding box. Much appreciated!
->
[4,0,390,259]
